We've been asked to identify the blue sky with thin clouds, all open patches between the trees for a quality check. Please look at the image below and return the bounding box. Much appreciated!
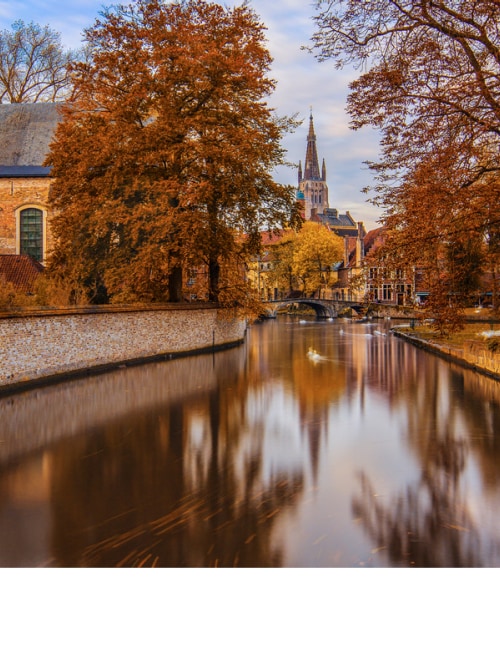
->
[0,0,379,229]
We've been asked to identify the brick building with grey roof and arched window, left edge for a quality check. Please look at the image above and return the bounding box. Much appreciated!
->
[0,103,60,263]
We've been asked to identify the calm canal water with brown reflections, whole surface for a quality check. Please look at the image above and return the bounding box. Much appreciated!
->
[0,317,500,568]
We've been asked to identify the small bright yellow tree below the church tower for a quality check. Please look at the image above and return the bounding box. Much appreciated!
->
[292,222,344,296]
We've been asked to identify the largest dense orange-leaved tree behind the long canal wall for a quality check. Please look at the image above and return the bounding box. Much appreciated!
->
[47,0,295,304]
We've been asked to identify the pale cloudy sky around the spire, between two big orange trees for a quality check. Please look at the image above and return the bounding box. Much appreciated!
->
[246,0,380,228]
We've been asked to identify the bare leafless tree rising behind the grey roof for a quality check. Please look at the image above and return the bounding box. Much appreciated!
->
[0,21,77,103]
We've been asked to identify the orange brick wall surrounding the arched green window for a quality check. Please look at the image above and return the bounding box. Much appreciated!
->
[0,177,52,255]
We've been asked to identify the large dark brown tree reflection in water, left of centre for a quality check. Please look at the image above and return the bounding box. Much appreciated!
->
[47,374,303,567]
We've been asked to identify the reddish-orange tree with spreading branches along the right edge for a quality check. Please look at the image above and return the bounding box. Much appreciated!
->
[313,0,500,328]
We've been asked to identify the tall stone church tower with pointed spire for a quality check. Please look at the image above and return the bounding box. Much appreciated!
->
[299,111,329,220]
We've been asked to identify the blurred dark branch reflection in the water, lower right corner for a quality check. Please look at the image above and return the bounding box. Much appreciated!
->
[352,439,500,568]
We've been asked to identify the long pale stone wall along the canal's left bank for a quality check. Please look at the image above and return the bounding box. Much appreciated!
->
[0,306,246,390]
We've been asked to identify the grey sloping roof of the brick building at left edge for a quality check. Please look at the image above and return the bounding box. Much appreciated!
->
[0,102,61,177]
